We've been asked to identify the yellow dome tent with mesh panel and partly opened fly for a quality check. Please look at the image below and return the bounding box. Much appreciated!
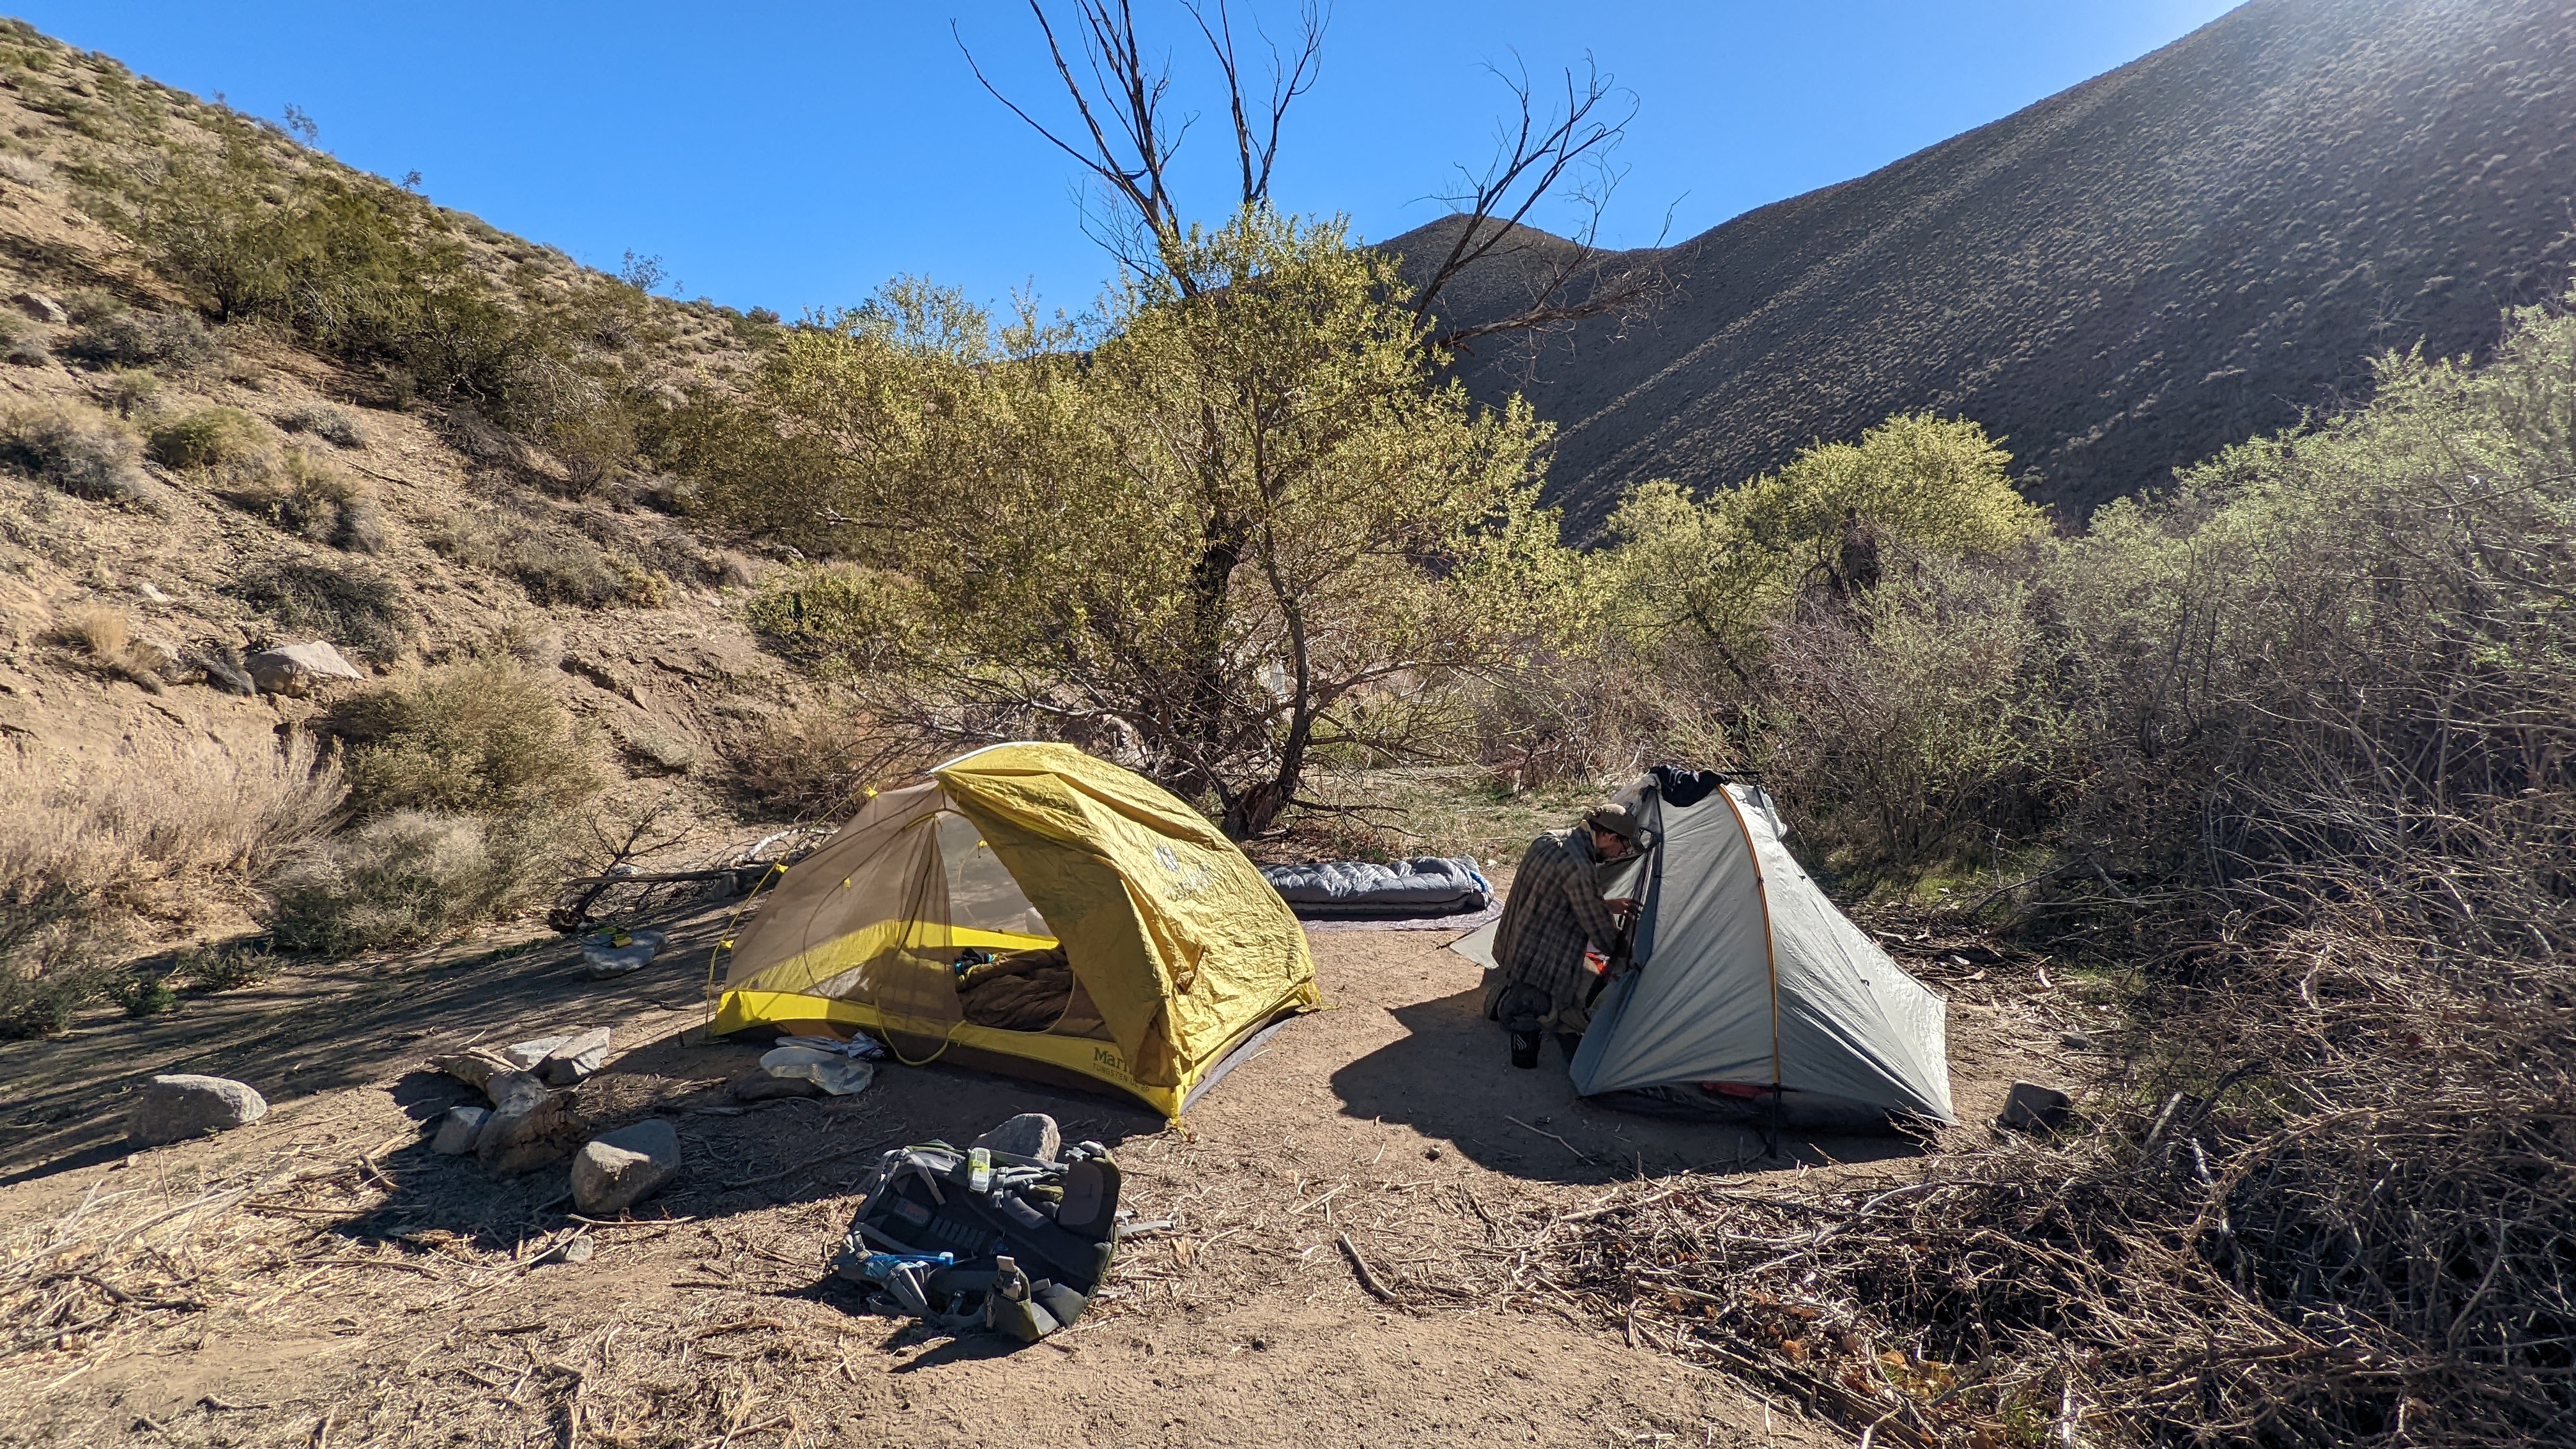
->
[714,745,1316,1116]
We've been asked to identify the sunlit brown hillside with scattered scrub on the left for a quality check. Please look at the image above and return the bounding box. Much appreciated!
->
[0,23,776,882]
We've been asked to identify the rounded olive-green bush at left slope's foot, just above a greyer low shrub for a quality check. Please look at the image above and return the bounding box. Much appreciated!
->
[330,657,600,820]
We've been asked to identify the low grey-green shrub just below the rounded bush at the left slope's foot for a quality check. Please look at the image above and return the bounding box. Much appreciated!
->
[268,809,556,951]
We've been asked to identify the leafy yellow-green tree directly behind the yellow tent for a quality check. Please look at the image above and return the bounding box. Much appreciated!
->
[696,209,1577,832]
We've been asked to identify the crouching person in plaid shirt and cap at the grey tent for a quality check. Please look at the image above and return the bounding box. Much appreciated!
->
[1483,807,1638,1068]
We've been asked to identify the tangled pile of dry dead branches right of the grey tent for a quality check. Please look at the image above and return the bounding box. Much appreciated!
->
[1515,892,2576,1446]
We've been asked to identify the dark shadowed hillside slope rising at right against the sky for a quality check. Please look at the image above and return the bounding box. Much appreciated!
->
[1388,0,2576,526]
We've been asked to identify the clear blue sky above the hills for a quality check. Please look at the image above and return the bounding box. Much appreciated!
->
[15,0,2231,314]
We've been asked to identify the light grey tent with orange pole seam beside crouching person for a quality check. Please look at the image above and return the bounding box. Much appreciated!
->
[1455,769,1958,1127]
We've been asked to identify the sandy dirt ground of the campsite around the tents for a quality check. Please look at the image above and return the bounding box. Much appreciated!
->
[0,913,2056,1449]
